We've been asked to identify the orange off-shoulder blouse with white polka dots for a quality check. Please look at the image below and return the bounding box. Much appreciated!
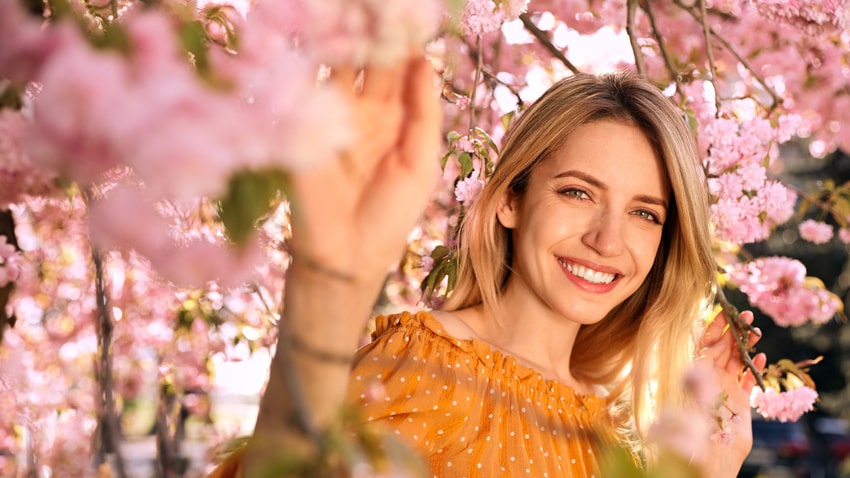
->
[211,311,613,478]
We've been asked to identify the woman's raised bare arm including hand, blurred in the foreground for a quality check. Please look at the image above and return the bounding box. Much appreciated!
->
[243,55,440,476]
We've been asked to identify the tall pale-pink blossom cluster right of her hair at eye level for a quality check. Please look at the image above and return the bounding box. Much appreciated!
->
[700,117,797,244]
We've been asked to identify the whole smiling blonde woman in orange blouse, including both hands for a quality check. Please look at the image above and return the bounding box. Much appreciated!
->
[212,58,763,477]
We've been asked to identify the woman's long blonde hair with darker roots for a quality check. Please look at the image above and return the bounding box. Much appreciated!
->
[443,72,715,444]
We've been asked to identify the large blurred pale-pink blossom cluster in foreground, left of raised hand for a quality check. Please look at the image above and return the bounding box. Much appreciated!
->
[12,5,347,198]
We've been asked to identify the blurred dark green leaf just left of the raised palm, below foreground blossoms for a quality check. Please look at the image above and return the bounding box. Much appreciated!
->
[218,169,289,244]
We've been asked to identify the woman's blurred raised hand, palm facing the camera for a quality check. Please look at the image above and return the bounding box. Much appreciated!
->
[292,55,441,284]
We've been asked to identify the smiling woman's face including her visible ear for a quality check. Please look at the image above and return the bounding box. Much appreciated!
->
[498,120,670,324]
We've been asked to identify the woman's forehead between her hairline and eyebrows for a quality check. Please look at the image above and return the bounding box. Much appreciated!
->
[532,119,669,198]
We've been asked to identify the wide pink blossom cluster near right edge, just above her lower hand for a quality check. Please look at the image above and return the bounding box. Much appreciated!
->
[726,257,841,327]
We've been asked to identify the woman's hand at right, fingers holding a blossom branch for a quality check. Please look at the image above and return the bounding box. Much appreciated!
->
[699,311,767,477]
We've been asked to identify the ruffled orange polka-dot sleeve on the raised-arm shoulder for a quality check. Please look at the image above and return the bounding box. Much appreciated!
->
[348,312,474,456]
